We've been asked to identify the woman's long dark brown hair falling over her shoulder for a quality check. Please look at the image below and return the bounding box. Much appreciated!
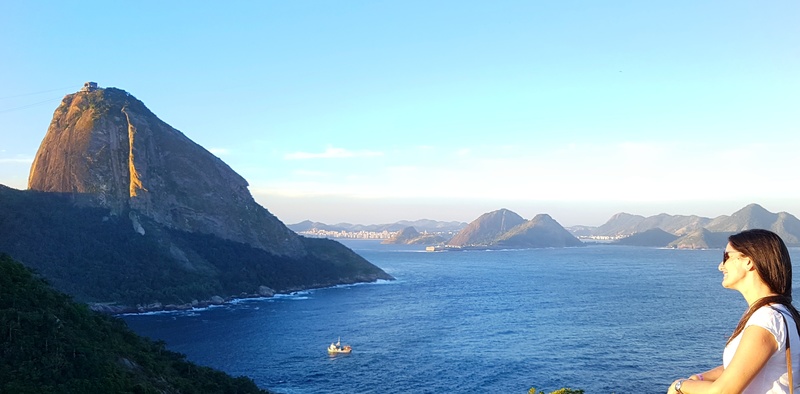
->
[728,229,800,343]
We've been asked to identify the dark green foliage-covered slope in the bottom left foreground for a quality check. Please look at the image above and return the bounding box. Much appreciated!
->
[0,254,267,394]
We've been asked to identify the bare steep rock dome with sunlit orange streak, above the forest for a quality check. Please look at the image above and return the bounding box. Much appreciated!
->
[28,88,306,256]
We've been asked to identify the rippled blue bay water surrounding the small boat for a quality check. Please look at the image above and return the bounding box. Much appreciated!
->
[124,241,797,394]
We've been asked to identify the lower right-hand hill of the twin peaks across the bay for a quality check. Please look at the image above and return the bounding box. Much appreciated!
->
[495,214,584,248]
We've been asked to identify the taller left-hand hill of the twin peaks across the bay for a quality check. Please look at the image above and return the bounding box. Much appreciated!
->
[447,208,525,247]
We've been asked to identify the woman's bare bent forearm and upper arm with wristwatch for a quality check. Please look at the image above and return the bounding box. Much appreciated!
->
[667,326,778,394]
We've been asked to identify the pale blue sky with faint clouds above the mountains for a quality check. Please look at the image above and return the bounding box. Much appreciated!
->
[0,0,800,226]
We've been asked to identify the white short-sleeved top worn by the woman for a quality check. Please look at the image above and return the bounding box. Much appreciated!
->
[722,304,800,394]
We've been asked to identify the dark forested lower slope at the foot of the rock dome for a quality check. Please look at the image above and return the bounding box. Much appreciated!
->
[0,186,391,306]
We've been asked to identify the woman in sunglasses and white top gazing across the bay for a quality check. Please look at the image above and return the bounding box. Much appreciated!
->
[667,230,800,394]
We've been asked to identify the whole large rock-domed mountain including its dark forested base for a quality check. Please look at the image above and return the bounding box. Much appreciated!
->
[0,88,392,307]
